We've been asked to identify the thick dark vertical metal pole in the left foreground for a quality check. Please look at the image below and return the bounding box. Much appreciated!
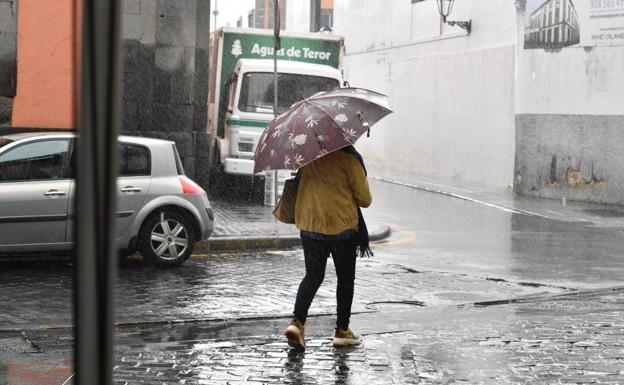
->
[74,0,121,385]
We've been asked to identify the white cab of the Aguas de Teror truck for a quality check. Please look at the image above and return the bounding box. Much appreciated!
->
[217,59,342,175]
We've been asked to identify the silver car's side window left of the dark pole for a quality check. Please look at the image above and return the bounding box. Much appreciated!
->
[0,139,69,182]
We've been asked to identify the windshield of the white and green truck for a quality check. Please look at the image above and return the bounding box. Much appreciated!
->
[238,72,340,113]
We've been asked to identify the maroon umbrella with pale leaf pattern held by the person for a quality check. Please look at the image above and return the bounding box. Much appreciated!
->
[254,88,392,173]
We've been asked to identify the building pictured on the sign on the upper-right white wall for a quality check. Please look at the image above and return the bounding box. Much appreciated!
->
[524,0,580,48]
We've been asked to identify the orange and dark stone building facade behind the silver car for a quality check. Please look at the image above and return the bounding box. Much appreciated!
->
[0,0,210,183]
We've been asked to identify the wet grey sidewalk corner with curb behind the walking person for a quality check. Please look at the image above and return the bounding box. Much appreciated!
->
[195,200,390,254]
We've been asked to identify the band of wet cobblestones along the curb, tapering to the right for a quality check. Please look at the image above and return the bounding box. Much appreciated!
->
[0,250,561,329]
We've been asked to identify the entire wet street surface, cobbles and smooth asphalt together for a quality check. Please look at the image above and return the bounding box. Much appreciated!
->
[0,181,624,385]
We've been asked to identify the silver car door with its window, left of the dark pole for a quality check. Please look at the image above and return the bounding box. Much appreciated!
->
[0,139,70,252]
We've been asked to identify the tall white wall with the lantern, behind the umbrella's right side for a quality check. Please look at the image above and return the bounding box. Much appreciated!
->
[334,0,518,187]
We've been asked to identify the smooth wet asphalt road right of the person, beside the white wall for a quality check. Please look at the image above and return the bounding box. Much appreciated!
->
[365,178,624,288]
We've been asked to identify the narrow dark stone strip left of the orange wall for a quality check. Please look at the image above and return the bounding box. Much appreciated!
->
[0,0,17,125]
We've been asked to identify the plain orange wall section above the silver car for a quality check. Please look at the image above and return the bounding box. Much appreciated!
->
[12,0,76,128]
